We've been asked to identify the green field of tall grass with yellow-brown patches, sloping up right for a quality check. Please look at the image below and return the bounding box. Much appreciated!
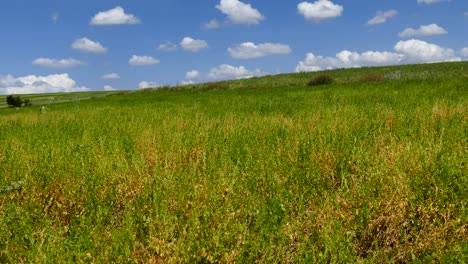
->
[0,62,468,263]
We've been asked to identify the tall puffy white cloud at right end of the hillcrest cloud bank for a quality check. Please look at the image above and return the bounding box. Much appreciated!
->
[394,39,460,63]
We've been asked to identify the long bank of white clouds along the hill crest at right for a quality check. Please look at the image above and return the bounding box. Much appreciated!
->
[296,39,460,72]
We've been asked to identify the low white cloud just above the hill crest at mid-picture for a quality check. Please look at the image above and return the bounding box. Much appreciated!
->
[206,64,266,80]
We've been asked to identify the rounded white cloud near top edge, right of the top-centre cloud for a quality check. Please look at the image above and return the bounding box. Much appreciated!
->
[297,0,344,22]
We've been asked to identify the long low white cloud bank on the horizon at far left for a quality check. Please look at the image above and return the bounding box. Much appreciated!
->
[0,73,90,94]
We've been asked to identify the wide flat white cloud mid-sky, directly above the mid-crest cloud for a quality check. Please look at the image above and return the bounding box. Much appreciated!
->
[228,42,291,59]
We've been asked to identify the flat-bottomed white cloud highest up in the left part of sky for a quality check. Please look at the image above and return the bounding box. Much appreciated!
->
[90,6,141,26]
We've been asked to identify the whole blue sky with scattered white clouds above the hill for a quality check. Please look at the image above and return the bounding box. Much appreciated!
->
[0,0,468,94]
